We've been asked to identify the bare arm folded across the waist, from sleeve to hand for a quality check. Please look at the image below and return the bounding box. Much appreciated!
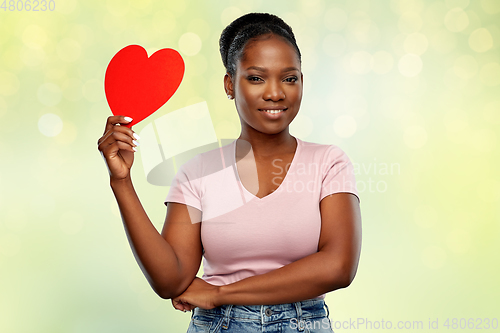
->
[172,193,361,310]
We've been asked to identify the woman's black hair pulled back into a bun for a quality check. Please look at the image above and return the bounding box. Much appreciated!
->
[219,13,301,76]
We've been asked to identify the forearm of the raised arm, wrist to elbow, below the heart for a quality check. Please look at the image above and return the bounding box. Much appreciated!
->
[110,178,182,298]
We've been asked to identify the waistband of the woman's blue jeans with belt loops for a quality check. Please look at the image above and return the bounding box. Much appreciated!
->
[192,298,329,326]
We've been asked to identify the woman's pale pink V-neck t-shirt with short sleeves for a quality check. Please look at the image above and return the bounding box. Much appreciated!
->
[164,138,359,298]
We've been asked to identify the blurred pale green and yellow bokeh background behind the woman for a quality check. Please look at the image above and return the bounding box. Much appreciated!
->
[0,0,500,333]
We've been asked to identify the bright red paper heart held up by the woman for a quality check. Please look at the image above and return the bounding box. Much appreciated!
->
[104,45,184,127]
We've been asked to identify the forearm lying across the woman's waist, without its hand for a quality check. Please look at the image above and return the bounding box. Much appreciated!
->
[217,252,353,305]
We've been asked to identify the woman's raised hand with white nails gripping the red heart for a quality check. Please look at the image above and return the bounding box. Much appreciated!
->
[97,116,139,180]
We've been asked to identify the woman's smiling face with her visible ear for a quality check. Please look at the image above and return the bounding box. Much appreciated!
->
[224,35,303,136]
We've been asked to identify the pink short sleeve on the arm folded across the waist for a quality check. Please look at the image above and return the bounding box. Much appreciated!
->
[320,145,359,201]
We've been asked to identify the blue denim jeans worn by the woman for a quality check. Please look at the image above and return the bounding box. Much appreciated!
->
[187,298,333,333]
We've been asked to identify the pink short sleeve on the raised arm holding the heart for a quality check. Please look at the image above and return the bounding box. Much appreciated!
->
[164,155,202,211]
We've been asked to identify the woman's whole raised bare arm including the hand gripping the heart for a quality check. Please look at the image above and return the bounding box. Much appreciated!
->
[98,116,202,298]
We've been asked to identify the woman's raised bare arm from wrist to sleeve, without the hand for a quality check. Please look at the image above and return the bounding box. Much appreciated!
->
[110,179,201,298]
